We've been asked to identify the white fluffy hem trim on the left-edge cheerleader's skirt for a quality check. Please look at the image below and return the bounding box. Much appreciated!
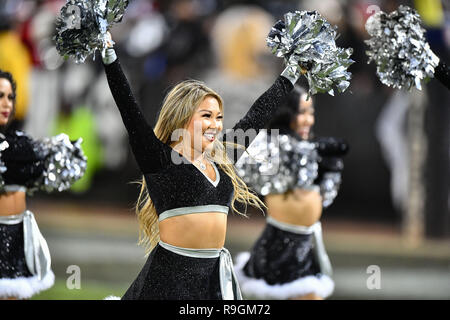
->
[0,270,55,299]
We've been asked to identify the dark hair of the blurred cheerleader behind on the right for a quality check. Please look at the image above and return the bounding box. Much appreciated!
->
[267,85,311,134]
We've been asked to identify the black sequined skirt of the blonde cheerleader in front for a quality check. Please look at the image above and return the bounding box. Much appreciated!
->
[118,243,240,300]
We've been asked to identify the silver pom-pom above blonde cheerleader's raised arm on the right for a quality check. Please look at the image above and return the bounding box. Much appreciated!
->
[267,11,354,95]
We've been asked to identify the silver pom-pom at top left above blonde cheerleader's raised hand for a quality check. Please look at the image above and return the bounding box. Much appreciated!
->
[54,0,128,63]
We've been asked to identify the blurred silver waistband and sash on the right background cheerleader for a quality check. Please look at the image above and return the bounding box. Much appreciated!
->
[266,216,333,277]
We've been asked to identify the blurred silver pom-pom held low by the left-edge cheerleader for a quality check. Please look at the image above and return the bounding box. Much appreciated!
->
[27,133,87,193]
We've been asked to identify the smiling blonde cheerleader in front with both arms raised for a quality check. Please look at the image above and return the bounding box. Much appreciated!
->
[96,28,304,300]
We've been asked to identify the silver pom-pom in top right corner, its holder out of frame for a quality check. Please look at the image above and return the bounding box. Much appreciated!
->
[365,6,439,90]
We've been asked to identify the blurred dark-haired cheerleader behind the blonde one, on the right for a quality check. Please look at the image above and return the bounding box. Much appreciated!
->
[235,86,347,300]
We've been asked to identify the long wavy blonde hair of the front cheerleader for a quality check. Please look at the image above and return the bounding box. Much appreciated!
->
[136,80,266,254]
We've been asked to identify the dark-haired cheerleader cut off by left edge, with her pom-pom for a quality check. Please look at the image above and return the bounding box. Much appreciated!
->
[0,70,86,299]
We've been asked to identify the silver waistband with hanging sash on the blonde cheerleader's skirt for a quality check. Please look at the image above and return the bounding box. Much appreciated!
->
[159,240,242,300]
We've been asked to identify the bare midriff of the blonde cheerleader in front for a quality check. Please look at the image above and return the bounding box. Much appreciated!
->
[159,212,227,249]
